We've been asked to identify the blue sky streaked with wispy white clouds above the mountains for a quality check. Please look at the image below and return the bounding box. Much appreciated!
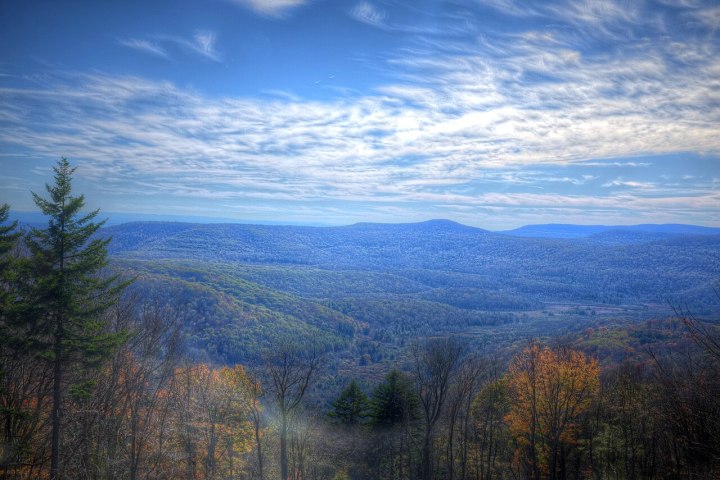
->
[0,0,720,229]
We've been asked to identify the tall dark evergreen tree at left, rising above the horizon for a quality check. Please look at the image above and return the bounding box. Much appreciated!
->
[23,158,126,480]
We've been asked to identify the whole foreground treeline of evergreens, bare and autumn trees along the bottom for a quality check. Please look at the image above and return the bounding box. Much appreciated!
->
[0,159,720,480]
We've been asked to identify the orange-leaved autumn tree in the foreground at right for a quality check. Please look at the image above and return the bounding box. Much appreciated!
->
[505,342,600,480]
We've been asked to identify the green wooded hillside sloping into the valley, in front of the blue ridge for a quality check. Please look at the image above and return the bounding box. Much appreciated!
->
[115,261,356,363]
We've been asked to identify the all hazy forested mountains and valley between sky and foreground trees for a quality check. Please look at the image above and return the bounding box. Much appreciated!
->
[94,220,720,361]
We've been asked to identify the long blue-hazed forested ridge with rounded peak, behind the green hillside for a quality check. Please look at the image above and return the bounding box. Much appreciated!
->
[108,218,720,311]
